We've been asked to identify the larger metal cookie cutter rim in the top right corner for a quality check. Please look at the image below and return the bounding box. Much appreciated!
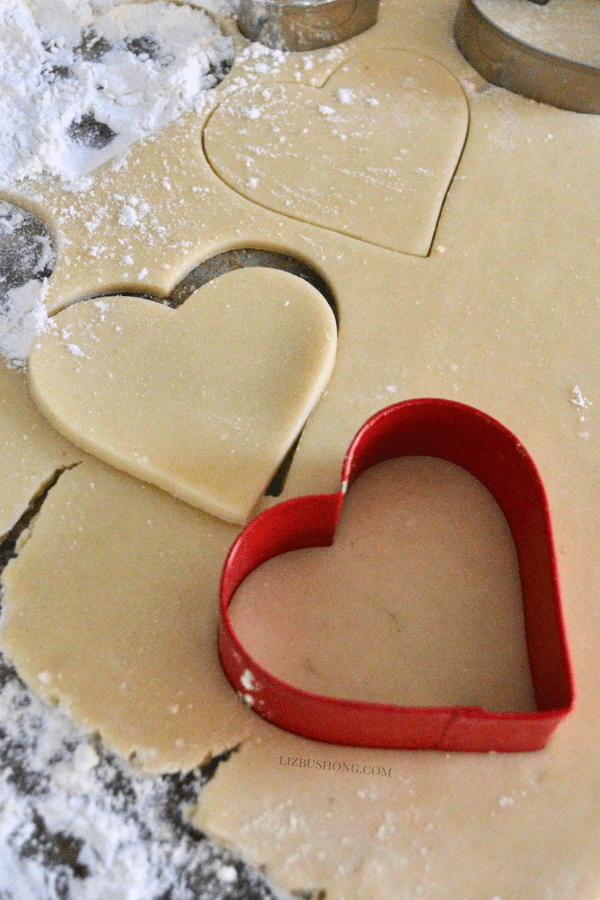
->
[454,0,600,115]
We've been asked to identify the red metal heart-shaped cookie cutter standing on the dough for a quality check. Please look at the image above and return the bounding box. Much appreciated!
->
[219,398,574,752]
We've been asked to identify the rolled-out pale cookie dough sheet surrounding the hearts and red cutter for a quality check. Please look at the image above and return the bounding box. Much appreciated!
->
[0,0,600,900]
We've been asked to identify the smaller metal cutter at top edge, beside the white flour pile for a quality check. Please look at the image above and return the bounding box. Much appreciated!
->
[238,0,379,51]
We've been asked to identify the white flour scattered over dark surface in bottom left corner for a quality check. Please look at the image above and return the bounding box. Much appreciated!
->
[0,658,288,900]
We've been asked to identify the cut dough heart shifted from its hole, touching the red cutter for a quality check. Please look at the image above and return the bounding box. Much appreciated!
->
[28,268,336,523]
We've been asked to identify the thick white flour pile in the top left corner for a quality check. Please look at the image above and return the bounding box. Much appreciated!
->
[0,0,234,186]
